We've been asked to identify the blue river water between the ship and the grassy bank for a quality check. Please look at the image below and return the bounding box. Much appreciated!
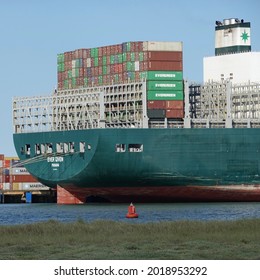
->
[0,203,260,225]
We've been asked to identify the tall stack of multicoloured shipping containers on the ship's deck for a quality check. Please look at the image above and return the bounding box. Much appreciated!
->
[57,41,184,118]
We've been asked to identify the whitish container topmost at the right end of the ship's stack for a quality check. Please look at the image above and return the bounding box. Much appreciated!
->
[143,41,183,52]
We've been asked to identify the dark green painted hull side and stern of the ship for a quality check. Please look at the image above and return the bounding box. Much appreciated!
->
[14,128,260,201]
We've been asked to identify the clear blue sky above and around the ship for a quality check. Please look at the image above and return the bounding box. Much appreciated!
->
[0,0,260,156]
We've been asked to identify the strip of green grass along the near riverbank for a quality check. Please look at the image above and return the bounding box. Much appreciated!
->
[0,219,260,260]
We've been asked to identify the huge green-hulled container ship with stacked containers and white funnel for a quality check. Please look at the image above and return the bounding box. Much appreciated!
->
[13,19,260,204]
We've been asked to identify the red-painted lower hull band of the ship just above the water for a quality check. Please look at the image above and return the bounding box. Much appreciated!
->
[57,185,260,204]
